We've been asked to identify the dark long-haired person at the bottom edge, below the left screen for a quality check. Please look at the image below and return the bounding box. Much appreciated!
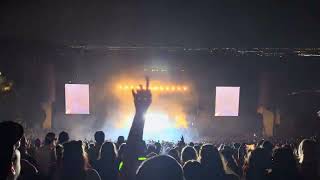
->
[55,141,101,180]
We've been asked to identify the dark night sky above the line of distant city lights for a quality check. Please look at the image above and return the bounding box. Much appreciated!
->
[0,0,320,47]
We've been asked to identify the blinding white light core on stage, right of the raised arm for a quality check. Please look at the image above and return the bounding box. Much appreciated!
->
[144,112,170,132]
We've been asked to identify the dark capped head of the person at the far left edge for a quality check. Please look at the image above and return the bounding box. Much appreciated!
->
[0,121,24,146]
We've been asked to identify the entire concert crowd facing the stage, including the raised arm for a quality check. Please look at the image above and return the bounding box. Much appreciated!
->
[0,77,320,180]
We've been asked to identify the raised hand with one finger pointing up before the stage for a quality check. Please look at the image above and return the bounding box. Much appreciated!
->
[132,77,152,114]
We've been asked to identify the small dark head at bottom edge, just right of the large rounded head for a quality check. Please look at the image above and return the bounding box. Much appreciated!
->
[183,160,202,180]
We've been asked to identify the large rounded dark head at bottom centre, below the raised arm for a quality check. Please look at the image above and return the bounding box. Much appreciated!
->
[136,155,184,180]
